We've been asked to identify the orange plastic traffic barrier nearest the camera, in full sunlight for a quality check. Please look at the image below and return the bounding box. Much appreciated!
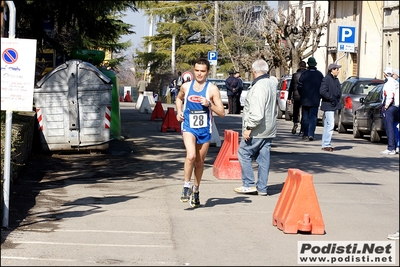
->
[272,169,325,235]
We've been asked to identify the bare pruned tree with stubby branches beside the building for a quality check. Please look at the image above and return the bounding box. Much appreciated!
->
[257,5,333,73]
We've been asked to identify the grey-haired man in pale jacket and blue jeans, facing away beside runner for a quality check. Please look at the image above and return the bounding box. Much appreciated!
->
[234,59,278,196]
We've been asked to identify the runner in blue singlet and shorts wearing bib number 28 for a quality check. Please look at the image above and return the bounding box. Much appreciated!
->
[176,58,225,208]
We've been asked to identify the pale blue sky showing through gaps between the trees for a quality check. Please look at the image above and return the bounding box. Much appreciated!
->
[120,1,278,52]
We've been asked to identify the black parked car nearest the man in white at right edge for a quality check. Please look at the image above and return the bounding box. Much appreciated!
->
[353,84,386,143]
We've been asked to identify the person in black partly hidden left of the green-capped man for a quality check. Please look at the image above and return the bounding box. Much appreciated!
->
[288,61,307,134]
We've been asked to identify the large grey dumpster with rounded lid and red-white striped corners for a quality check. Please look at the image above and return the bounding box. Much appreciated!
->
[33,60,112,151]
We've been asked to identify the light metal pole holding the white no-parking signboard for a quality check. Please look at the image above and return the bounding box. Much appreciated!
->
[2,1,16,230]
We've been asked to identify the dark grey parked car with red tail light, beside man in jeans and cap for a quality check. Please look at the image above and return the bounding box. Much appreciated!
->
[335,77,384,133]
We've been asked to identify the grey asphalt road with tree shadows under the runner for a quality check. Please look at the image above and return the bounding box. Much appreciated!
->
[1,102,399,266]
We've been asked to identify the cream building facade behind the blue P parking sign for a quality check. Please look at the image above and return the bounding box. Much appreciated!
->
[278,1,399,81]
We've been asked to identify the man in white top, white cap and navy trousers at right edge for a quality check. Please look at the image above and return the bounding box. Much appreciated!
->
[381,68,399,155]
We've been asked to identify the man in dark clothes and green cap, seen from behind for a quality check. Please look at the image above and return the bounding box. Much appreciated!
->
[297,57,324,141]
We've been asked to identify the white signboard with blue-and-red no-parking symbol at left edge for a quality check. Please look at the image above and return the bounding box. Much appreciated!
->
[1,38,36,111]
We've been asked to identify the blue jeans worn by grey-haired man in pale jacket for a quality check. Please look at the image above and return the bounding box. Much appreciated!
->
[238,138,272,193]
